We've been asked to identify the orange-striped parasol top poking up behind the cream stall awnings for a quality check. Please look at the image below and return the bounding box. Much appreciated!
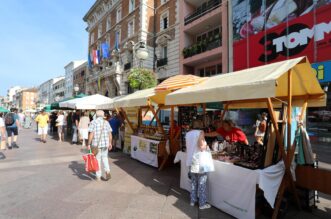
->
[155,75,207,92]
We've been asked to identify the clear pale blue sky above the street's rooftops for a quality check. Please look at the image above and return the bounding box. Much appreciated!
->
[0,0,95,96]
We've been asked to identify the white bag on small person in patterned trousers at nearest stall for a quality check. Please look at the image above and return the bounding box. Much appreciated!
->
[191,151,215,173]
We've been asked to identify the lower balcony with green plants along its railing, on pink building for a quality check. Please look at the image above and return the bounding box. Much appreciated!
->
[183,35,222,59]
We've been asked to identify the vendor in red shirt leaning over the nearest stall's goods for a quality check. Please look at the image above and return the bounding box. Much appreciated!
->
[205,119,249,145]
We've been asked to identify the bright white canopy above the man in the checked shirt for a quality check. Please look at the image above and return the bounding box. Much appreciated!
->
[59,94,113,110]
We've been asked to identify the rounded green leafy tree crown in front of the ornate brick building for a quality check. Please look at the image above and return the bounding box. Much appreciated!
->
[128,68,156,90]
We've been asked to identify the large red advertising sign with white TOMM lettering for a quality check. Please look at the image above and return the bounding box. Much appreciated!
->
[233,4,331,70]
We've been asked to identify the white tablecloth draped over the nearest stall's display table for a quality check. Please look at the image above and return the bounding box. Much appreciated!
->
[175,151,285,218]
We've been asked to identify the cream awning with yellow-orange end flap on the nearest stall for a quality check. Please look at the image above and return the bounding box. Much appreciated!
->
[165,57,326,108]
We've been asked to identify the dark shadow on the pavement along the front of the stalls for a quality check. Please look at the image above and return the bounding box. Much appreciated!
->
[109,152,232,218]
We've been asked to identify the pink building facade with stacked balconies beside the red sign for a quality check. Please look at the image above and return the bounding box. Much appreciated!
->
[179,0,228,77]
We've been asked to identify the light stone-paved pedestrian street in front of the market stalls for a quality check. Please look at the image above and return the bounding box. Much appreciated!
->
[0,130,331,219]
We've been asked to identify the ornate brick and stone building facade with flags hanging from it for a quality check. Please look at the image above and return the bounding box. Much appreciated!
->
[83,0,179,97]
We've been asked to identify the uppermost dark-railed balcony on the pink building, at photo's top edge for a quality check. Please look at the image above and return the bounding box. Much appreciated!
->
[184,0,222,25]
